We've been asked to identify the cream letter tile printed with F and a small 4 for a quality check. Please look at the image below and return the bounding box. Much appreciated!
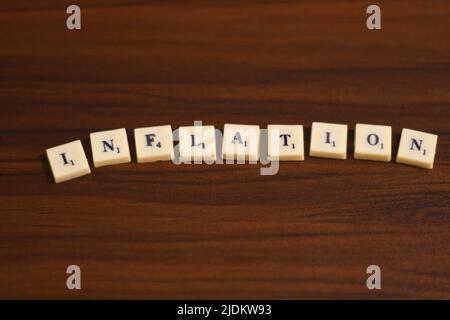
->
[134,125,173,163]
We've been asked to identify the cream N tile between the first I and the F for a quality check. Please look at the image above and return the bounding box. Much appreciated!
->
[91,129,131,168]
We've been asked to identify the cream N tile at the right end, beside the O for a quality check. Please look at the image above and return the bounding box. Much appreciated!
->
[397,129,438,169]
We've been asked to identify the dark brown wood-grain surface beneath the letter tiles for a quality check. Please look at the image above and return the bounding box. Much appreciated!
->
[0,0,450,299]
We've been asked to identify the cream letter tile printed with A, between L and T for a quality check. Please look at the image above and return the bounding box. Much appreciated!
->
[222,124,260,162]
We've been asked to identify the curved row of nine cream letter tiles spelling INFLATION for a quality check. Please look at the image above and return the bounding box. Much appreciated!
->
[47,122,437,183]
